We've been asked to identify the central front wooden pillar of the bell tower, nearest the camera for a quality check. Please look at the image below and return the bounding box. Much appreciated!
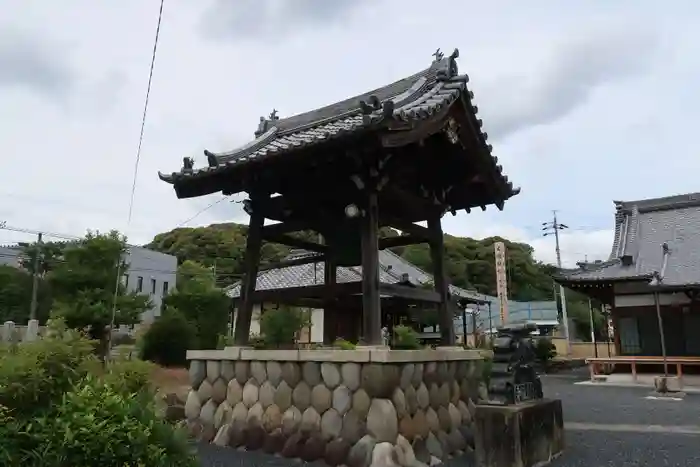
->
[360,190,383,345]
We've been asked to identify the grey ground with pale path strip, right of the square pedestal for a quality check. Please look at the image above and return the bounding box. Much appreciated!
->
[544,375,700,467]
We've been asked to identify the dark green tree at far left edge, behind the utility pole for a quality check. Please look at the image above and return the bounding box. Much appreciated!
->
[0,266,51,324]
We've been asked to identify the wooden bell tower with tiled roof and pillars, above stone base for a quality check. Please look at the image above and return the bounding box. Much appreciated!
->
[159,49,519,346]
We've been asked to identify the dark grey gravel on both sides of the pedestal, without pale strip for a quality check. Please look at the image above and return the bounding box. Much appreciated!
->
[199,372,700,467]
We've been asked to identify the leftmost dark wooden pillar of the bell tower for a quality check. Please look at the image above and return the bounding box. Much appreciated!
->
[233,210,265,346]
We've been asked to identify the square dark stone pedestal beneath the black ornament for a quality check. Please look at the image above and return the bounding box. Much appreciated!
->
[475,399,564,467]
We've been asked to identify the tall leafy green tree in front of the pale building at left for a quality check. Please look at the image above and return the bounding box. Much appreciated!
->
[47,231,151,350]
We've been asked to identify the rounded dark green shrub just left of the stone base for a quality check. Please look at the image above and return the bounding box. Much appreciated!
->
[140,308,195,367]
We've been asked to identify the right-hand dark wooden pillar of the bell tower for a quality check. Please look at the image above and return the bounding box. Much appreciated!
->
[428,216,456,346]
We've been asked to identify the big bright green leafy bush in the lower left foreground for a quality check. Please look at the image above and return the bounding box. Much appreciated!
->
[0,323,196,467]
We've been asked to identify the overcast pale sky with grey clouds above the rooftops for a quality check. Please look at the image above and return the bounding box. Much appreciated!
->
[0,0,700,265]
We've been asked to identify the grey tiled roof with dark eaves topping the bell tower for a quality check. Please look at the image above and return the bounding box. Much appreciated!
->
[159,51,520,221]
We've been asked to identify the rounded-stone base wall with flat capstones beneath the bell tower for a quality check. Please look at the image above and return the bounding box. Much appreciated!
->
[185,348,487,467]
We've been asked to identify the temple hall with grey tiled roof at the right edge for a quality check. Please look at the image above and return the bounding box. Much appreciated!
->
[556,193,700,357]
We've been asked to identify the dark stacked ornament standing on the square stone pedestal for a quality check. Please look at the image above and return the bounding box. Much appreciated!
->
[489,323,543,405]
